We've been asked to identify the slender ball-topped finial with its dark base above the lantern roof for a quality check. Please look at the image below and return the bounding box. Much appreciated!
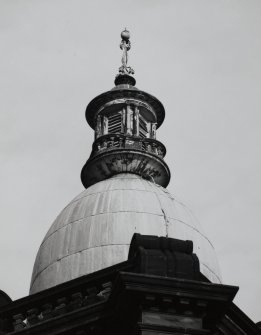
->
[115,28,136,86]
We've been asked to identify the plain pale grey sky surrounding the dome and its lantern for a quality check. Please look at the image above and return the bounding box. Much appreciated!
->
[0,0,261,322]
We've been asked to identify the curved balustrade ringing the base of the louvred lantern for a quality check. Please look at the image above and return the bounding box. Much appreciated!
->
[91,134,166,158]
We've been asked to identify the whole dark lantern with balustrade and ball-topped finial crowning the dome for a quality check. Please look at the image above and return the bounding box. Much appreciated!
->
[81,28,170,188]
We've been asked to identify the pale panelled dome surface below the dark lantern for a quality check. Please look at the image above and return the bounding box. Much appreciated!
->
[30,174,221,294]
